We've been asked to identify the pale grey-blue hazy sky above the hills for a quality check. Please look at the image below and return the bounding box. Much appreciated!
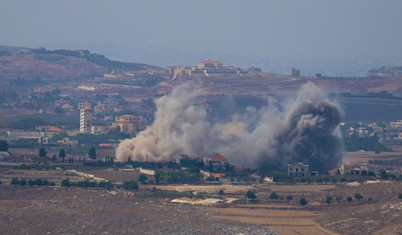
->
[0,0,402,72]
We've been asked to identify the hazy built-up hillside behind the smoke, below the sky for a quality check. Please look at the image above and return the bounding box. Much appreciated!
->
[0,46,402,123]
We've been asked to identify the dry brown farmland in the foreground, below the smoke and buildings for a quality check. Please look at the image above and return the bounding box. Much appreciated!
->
[0,165,402,234]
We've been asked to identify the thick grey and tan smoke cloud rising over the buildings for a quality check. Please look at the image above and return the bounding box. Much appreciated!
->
[116,83,342,171]
